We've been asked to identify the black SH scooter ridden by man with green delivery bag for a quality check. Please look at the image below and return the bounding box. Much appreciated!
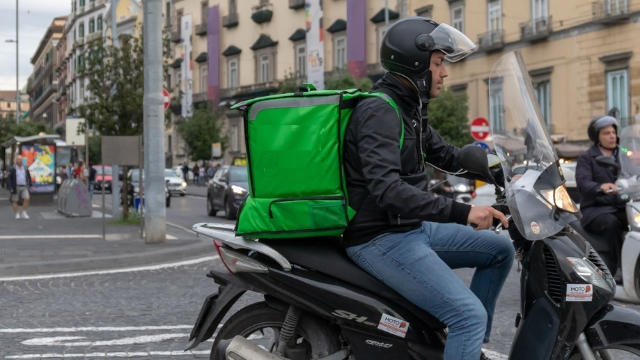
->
[187,52,640,360]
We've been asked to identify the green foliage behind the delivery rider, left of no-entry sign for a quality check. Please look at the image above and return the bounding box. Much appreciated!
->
[429,89,473,146]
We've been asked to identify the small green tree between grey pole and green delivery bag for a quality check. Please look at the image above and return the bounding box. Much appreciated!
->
[176,104,227,161]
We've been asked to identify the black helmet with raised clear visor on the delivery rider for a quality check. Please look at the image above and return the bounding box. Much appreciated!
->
[380,17,477,99]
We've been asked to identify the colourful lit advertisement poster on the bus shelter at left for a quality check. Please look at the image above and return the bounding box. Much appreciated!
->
[22,144,56,193]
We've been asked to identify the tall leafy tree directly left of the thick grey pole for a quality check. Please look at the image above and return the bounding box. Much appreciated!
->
[76,34,144,136]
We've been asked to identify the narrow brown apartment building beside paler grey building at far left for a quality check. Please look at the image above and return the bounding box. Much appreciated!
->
[27,16,67,127]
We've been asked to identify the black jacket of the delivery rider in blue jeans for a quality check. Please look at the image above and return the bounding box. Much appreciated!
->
[344,73,471,247]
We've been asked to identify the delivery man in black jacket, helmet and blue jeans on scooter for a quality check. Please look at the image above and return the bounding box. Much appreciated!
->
[344,17,514,360]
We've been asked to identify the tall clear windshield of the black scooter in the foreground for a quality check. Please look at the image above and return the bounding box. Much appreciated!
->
[489,51,577,240]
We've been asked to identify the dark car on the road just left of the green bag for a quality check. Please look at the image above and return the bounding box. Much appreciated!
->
[207,165,249,219]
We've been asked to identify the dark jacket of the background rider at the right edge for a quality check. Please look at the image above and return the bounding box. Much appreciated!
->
[576,145,624,227]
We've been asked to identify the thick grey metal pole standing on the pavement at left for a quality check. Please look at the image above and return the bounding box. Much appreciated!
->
[143,0,167,244]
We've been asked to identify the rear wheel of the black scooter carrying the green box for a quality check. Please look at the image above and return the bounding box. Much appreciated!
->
[210,302,340,360]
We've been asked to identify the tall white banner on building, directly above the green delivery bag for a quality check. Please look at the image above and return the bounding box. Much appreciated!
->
[305,0,324,90]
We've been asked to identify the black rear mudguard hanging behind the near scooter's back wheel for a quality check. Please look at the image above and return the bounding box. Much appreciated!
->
[185,270,249,351]
